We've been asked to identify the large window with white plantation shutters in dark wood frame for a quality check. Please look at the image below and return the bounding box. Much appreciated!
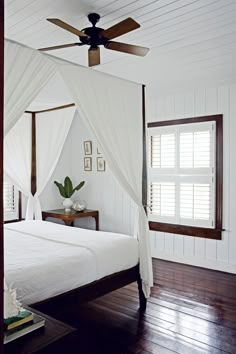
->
[148,115,222,238]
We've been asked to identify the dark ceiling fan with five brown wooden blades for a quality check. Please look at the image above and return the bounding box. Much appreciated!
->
[39,13,149,66]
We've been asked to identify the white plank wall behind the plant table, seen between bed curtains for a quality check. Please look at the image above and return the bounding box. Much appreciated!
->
[39,113,135,235]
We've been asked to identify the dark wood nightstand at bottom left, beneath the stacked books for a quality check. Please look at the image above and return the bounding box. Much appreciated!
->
[4,306,76,354]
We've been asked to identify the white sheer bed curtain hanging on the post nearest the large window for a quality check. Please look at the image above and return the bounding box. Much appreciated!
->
[59,65,153,297]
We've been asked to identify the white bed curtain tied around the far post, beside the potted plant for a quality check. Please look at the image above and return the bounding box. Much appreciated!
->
[4,107,76,220]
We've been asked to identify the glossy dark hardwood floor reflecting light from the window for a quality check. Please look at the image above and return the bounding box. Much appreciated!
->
[42,260,236,354]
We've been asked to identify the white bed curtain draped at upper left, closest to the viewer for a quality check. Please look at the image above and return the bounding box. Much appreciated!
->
[4,40,56,135]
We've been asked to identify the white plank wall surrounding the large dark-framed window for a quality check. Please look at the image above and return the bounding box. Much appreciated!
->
[148,85,236,273]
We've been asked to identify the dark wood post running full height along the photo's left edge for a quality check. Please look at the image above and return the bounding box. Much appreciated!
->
[0,0,4,346]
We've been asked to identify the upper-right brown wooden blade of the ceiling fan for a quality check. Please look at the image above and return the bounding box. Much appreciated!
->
[101,17,140,39]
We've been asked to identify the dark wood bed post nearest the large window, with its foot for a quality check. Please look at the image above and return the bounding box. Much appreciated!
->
[137,85,147,312]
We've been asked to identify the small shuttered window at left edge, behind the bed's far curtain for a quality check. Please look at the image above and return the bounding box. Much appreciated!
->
[3,182,18,221]
